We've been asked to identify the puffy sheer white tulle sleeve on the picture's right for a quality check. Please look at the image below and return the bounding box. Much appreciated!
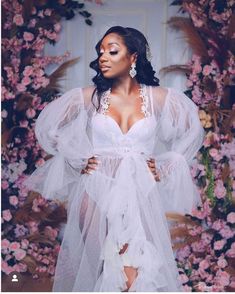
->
[153,88,204,213]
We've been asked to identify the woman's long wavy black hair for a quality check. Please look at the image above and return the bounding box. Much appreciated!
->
[90,26,159,109]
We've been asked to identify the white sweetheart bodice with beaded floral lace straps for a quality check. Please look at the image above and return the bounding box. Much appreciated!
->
[91,86,157,154]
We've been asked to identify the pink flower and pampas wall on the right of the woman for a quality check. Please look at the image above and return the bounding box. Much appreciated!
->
[162,0,235,292]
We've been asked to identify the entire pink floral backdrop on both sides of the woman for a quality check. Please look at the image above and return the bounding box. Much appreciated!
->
[2,0,235,292]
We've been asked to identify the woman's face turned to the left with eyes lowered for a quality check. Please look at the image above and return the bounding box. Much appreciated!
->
[99,33,136,79]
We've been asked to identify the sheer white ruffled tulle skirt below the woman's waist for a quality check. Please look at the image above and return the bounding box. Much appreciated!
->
[48,155,190,292]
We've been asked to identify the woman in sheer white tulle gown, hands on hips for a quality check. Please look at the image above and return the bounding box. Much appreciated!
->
[23,26,203,292]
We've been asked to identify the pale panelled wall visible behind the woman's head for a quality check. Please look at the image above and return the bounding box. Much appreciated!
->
[45,0,191,91]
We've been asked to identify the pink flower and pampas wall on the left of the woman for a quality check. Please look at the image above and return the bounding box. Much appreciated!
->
[2,0,101,278]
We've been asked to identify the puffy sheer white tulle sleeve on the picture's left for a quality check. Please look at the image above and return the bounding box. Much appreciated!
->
[24,88,93,201]
